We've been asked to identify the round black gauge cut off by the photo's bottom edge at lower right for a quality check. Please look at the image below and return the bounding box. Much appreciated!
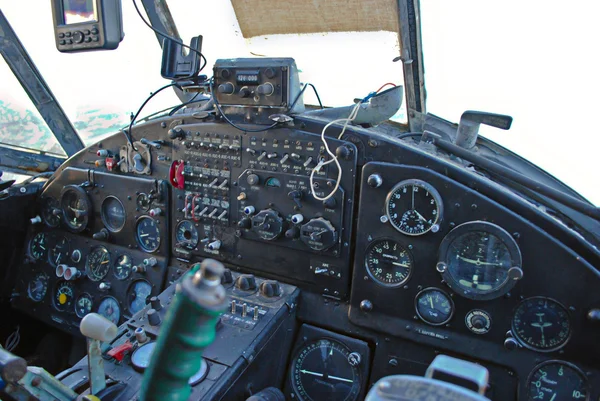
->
[527,361,590,401]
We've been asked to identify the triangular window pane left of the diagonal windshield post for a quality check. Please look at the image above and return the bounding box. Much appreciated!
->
[0,59,66,156]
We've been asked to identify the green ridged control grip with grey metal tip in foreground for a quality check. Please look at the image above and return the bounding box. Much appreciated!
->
[139,259,227,401]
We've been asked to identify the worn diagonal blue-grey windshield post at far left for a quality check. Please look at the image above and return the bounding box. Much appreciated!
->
[0,10,84,156]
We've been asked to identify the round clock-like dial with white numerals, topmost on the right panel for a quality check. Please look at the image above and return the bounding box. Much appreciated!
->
[385,179,443,236]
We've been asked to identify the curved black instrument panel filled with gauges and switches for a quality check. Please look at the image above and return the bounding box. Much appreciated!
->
[10,114,600,400]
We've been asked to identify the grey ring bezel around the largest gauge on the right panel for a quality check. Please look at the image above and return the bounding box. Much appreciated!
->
[437,220,523,301]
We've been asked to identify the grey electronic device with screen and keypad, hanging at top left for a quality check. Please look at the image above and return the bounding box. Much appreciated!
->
[52,0,124,53]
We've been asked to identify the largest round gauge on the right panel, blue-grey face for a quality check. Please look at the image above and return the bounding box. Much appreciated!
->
[437,221,523,300]
